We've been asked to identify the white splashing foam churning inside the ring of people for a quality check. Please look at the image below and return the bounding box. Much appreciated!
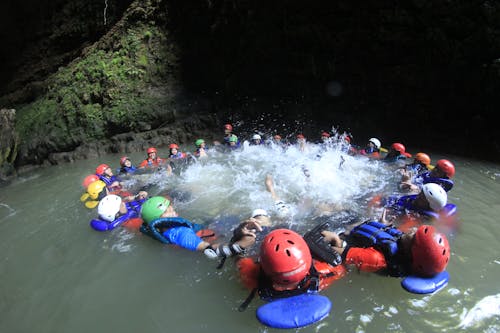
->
[130,135,390,233]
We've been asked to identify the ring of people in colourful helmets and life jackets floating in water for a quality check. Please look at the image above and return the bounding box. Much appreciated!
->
[81,124,456,320]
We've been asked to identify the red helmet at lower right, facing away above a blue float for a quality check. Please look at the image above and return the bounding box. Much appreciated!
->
[411,225,450,277]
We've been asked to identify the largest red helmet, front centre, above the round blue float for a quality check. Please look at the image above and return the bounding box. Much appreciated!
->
[260,229,312,287]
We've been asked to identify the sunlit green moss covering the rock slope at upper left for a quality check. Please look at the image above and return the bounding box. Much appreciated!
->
[16,5,177,154]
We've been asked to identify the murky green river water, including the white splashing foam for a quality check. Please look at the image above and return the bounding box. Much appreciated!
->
[0,136,500,333]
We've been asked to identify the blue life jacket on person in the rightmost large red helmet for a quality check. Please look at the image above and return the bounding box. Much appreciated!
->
[347,221,403,275]
